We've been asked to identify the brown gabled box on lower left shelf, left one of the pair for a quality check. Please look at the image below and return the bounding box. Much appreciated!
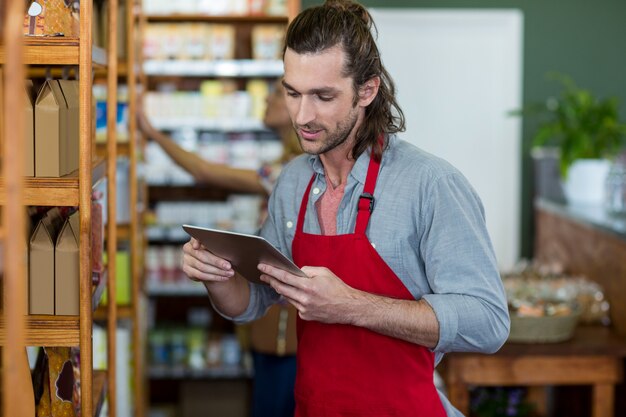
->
[28,207,62,315]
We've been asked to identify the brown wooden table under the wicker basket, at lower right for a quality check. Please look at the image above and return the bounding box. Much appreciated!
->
[437,326,626,417]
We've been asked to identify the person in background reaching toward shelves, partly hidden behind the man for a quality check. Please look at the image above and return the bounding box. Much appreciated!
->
[138,83,302,417]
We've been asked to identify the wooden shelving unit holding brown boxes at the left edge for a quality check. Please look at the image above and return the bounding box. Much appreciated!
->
[0,0,117,417]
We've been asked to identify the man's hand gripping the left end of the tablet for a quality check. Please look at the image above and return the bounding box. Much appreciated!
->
[183,238,235,283]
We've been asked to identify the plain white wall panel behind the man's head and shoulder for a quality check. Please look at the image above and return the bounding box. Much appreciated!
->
[372,9,523,269]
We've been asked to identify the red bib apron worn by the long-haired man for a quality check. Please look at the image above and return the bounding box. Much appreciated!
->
[292,154,446,417]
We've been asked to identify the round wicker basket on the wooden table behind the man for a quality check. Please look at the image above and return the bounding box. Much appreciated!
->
[508,311,580,343]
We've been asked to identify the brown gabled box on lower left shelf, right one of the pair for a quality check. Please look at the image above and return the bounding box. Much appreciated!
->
[54,212,80,316]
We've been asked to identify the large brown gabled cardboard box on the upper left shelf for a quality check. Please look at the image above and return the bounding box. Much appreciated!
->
[35,80,79,177]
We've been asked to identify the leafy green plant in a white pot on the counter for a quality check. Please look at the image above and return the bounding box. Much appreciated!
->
[515,74,626,204]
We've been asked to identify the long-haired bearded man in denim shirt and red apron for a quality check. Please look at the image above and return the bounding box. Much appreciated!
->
[183,1,509,417]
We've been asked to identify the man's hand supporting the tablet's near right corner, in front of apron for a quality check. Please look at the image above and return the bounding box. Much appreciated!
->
[259,264,361,324]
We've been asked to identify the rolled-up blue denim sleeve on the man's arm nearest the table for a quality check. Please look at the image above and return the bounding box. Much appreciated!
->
[419,174,510,353]
